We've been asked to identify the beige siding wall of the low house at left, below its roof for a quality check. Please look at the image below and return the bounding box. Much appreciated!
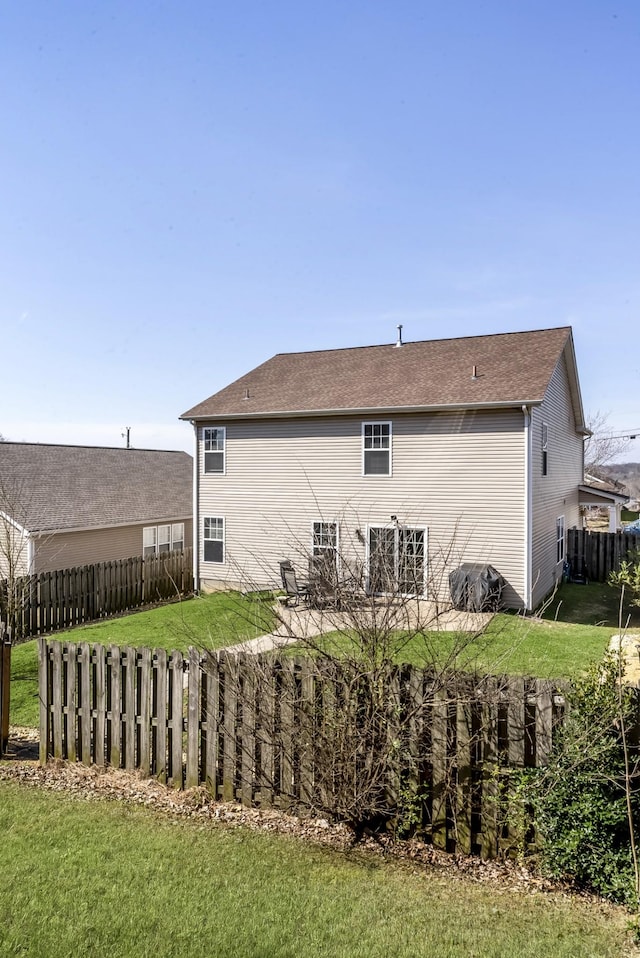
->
[34,519,193,572]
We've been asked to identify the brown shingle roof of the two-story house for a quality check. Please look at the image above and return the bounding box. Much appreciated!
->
[181,327,573,420]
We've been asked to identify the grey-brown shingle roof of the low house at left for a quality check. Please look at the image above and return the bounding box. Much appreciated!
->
[0,442,193,532]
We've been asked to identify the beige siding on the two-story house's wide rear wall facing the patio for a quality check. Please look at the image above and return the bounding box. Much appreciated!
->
[197,407,525,605]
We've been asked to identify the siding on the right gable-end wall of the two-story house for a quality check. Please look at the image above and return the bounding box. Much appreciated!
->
[531,357,584,609]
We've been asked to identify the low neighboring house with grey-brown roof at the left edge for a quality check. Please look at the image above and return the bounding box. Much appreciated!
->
[0,442,193,578]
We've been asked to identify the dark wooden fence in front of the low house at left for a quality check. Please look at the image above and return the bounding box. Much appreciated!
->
[0,549,193,638]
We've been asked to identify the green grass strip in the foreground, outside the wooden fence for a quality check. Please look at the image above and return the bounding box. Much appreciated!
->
[0,782,628,958]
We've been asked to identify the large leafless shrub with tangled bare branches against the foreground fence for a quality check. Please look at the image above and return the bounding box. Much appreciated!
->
[198,520,516,838]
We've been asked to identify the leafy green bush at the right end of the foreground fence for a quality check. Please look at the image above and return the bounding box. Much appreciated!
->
[525,655,640,908]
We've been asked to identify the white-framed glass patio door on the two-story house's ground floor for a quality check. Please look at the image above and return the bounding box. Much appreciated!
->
[368,526,427,595]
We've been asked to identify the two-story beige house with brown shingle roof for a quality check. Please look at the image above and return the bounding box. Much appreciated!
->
[181,327,588,609]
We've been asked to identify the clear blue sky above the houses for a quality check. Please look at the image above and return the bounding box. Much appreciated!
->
[0,0,640,459]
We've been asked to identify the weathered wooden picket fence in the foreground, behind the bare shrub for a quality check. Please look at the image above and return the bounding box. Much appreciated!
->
[40,638,564,857]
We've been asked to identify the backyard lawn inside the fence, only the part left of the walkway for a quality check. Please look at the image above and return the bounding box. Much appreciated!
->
[10,592,273,727]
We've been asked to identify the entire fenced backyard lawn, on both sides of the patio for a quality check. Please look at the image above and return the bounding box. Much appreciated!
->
[11,582,640,727]
